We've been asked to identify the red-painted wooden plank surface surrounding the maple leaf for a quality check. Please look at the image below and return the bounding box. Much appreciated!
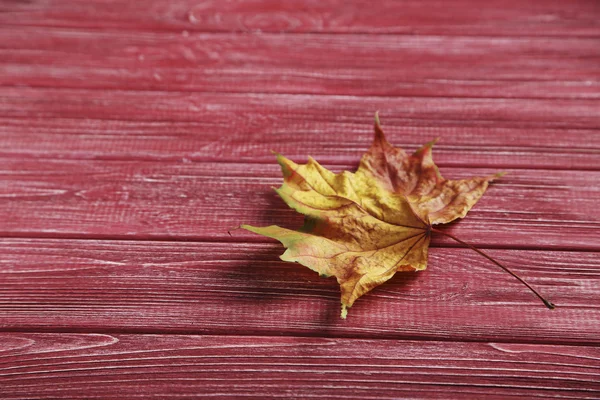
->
[0,0,600,399]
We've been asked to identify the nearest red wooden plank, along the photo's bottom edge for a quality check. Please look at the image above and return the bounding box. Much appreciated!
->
[0,333,600,399]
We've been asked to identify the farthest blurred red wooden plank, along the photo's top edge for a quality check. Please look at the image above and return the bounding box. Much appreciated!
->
[0,0,600,36]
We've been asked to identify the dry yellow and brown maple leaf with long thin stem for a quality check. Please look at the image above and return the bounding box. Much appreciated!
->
[241,115,551,318]
